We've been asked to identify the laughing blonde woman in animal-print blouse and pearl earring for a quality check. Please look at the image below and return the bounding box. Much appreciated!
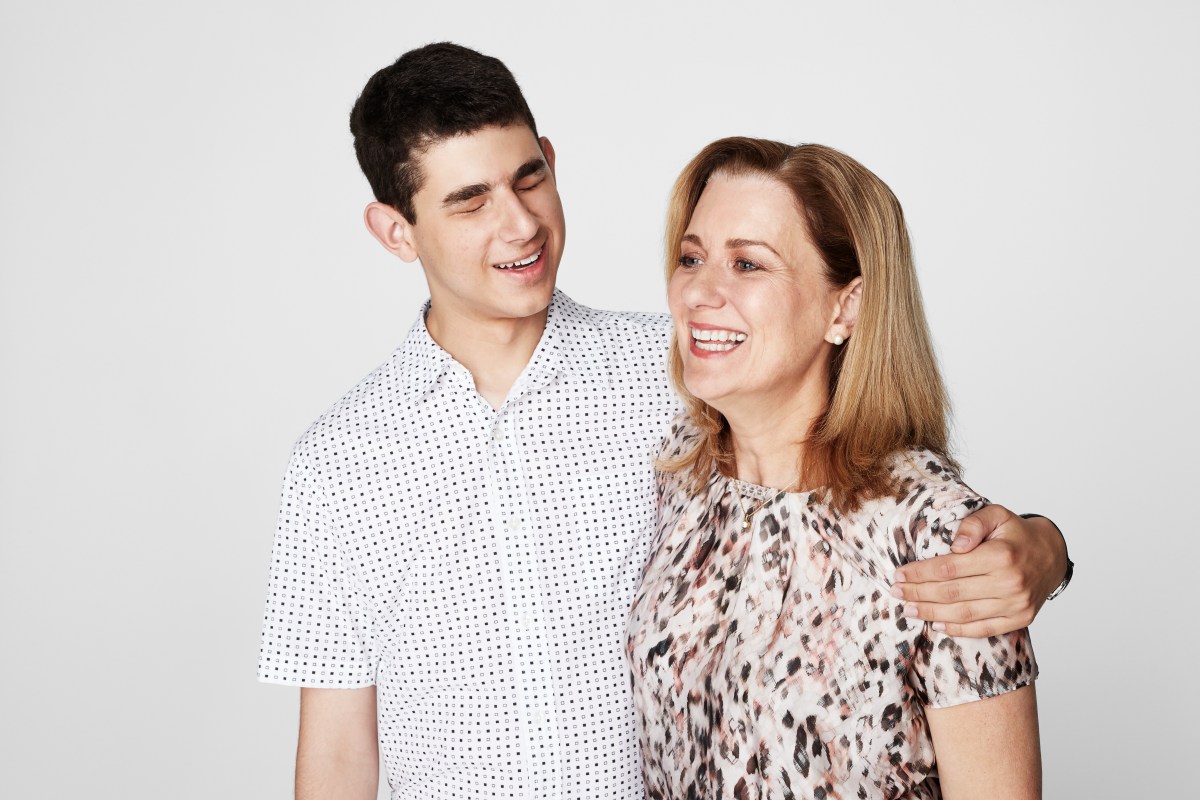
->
[626,138,1040,799]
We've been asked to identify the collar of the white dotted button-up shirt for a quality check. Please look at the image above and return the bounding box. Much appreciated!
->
[394,289,590,403]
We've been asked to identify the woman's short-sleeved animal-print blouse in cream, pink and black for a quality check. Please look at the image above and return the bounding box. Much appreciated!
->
[626,420,1037,800]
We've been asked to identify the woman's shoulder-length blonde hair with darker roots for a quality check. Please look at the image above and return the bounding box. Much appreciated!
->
[660,137,953,510]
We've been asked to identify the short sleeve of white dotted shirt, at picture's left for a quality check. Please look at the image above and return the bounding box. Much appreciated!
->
[258,446,376,688]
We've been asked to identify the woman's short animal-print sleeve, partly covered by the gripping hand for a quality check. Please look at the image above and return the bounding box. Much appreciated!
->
[908,476,1038,708]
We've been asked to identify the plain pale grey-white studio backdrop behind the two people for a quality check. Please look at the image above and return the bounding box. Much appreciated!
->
[0,0,1200,799]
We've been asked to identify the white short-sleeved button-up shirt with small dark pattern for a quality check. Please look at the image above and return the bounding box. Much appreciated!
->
[258,293,678,800]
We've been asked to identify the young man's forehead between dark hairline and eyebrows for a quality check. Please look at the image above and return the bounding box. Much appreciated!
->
[420,125,542,192]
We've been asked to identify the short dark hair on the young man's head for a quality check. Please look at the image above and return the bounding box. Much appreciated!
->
[350,42,538,222]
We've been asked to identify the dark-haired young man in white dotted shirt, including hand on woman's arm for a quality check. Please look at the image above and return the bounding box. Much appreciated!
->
[259,43,1067,800]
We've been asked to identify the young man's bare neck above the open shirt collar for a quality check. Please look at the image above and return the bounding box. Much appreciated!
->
[425,307,548,408]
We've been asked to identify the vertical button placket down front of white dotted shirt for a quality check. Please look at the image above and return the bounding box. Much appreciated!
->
[487,379,562,798]
